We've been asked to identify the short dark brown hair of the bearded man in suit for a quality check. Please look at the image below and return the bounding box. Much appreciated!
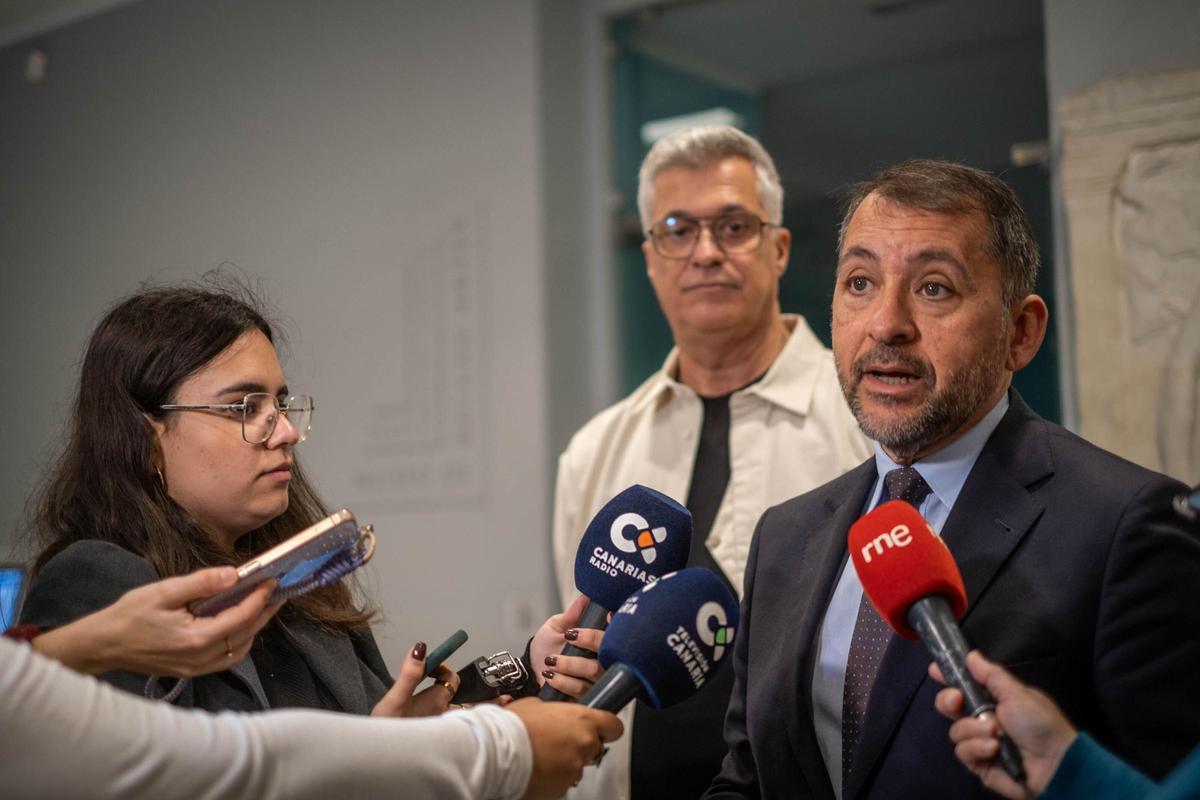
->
[838,158,1042,307]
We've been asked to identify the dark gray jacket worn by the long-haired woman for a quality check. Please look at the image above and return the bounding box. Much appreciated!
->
[20,540,391,714]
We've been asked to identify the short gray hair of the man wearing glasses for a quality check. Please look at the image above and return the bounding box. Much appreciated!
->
[637,125,784,230]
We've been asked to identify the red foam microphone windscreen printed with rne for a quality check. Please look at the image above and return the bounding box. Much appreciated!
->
[847,500,967,639]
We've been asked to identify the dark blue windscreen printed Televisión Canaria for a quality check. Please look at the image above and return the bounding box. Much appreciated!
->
[600,567,738,709]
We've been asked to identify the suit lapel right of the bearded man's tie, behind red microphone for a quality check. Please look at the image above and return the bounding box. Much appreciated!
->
[842,391,1054,800]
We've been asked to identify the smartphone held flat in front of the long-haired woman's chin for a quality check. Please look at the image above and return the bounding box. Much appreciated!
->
[187,509,370,616]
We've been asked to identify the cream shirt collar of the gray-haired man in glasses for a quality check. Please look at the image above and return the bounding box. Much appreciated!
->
[640,314,827,416]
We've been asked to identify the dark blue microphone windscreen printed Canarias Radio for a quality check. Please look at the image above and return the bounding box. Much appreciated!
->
[575,483,691,610]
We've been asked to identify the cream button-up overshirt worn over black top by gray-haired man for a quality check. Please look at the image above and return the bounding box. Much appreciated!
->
[553,314,871,800]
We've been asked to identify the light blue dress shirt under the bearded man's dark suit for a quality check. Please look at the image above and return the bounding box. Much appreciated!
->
[812,392,1008,799]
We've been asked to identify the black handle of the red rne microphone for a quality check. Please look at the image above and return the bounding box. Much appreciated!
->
[905,595,1025,786]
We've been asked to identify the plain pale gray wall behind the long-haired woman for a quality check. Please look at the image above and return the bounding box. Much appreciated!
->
[0,0,564,664]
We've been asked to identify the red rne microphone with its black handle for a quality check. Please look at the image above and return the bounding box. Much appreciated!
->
[847,500,1025,784]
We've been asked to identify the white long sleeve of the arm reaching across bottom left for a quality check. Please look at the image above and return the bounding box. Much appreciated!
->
[0,637,533,800]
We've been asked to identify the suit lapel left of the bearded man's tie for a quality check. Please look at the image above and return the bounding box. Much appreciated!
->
[784,458,876,795]
